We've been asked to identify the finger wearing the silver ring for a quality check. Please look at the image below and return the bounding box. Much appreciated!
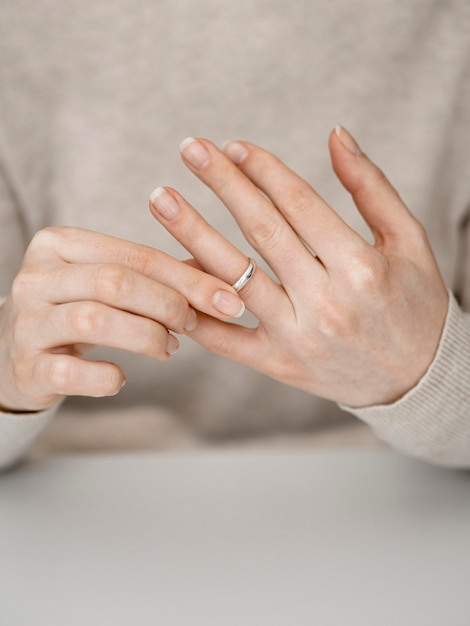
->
[150,187,289,323]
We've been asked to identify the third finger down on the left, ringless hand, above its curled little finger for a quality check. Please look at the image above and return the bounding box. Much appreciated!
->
[32,302,178,360]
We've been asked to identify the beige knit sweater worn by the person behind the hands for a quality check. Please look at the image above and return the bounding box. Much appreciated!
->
[0,0,470,465]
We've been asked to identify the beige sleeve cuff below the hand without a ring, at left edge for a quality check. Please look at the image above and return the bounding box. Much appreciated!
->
[0,406,58,472]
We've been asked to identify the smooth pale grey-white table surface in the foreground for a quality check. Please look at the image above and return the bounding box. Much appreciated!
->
[0,450,470,626]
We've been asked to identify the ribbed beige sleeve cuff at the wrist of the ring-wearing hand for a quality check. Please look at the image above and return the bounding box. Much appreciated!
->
[341,294,470,467]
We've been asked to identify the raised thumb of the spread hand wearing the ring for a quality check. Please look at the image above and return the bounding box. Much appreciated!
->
[329,126,418,247]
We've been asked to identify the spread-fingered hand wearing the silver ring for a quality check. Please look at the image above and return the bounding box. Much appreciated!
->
[153,128,448,407]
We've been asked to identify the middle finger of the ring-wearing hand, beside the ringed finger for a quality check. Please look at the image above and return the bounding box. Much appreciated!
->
[181,139,323,290]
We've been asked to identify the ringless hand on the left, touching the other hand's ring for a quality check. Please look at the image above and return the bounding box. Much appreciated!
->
[0,228,244,412]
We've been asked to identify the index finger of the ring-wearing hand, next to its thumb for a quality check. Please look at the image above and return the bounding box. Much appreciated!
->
[220,142,364,269]
